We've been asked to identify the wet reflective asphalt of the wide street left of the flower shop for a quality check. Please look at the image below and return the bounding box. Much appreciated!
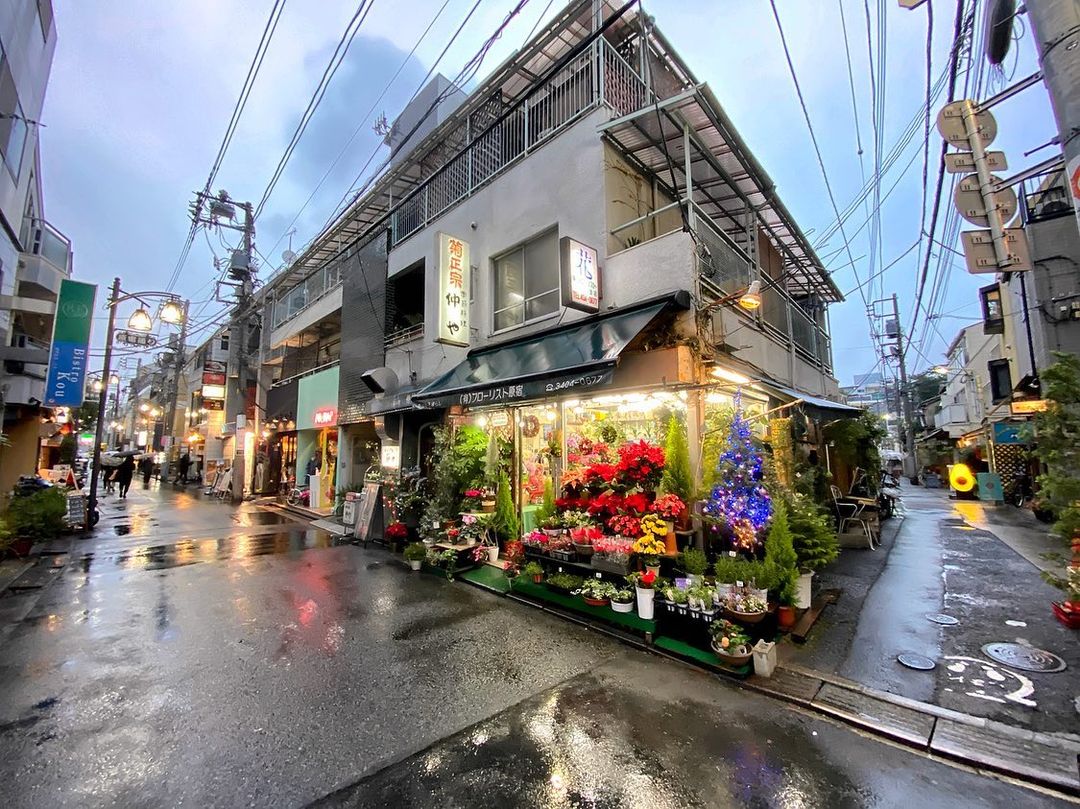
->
[0,483,1071,808]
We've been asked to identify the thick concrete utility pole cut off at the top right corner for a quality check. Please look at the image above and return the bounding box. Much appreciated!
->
[1025,0,1080,236]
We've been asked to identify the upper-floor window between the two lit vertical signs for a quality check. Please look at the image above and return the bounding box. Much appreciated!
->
[495,230,561,332]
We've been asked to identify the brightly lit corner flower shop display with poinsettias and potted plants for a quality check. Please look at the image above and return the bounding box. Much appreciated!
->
[380,352,851,674]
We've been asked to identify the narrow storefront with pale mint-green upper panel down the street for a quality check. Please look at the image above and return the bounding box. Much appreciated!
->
[298,366,338,514]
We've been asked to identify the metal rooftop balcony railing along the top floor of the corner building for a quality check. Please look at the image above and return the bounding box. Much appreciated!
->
[390,39,647,247]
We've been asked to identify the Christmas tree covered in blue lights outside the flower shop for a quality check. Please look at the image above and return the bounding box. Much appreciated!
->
[703,396,772,552]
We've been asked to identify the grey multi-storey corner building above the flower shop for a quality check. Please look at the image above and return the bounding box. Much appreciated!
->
[254,0,854,511]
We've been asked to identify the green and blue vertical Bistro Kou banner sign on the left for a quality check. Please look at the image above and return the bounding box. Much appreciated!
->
[45,279,97,407]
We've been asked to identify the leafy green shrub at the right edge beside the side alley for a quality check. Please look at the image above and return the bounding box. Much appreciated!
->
[1036,352,1080,601]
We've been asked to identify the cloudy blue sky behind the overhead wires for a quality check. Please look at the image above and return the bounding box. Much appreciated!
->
[41,0,1056,385]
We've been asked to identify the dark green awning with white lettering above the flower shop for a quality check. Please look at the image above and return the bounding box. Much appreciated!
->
[413,293,687,407]
